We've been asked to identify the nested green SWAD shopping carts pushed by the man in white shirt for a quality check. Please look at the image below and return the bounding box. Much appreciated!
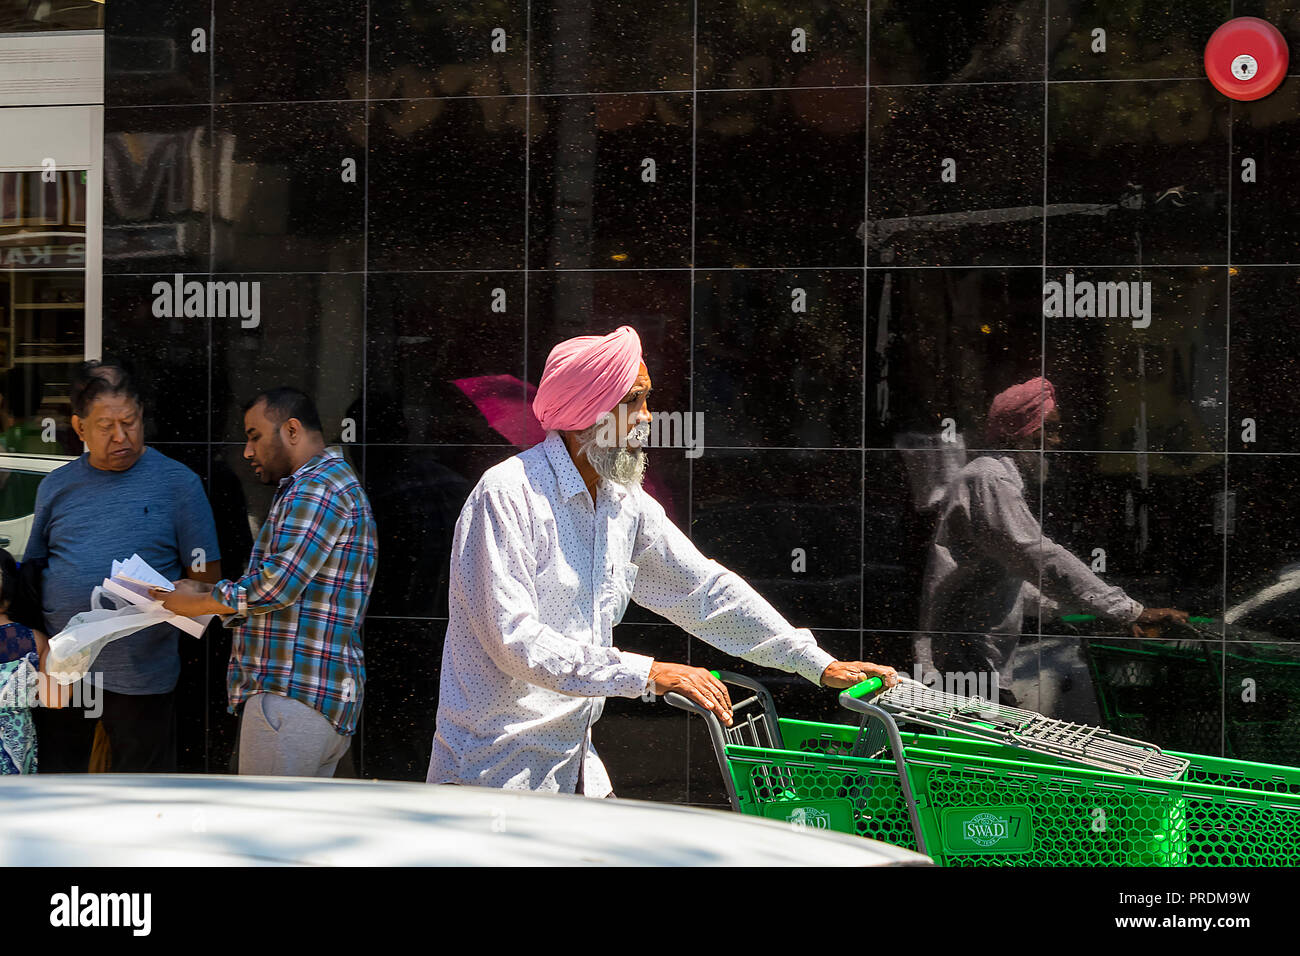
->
[668,672,1300,866]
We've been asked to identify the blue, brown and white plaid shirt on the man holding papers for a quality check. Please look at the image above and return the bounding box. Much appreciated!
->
[212,451,377,735]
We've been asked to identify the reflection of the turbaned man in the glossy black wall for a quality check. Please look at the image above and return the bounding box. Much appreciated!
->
[918,378,1187,704]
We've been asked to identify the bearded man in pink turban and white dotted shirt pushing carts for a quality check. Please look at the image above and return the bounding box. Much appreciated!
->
[428,325,897,796]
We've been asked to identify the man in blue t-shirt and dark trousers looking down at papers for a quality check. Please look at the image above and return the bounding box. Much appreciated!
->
[25,362,221,773]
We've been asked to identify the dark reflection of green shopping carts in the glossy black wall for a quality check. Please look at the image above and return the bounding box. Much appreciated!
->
[1083,619,1300,763]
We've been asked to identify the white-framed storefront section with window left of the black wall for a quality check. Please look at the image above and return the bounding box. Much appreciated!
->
[0,21,104,454]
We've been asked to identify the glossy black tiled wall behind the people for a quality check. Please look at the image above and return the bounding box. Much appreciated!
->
[104,0,1300,805]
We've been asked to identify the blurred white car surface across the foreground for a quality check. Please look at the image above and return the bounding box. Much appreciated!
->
[0,774,931,866]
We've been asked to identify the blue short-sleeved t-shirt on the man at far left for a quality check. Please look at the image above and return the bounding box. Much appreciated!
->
[23,447,221,695]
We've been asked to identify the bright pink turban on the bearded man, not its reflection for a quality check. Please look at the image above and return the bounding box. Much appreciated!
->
[533,325,641,432]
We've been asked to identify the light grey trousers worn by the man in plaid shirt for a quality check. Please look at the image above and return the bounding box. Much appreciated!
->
[239,693,352,777]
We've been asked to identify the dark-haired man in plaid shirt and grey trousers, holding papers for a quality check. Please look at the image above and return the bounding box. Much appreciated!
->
[155,388,376,777]
